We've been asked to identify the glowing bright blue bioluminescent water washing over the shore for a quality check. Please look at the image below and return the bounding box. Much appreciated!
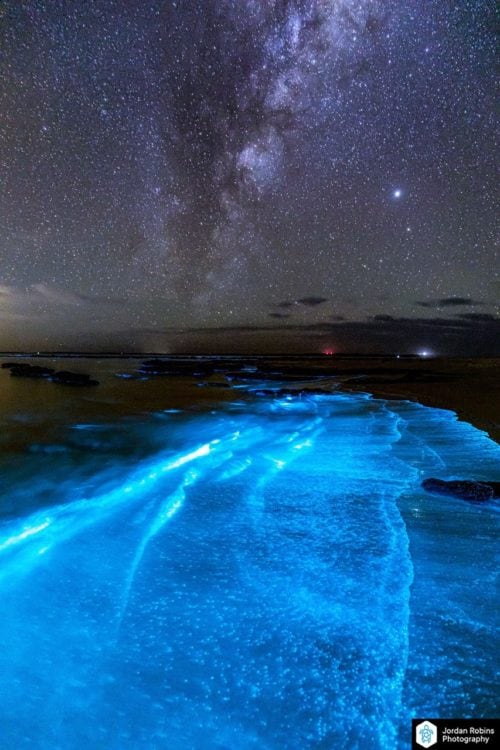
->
[0,394,500,750]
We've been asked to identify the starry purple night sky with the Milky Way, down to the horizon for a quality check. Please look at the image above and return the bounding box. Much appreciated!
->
[0,0,500,355]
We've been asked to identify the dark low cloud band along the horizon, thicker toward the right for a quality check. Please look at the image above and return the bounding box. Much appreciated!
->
[2,314,500,357]
